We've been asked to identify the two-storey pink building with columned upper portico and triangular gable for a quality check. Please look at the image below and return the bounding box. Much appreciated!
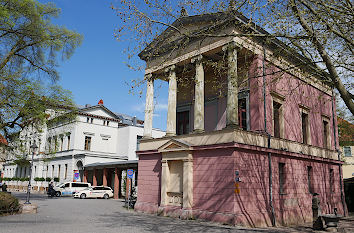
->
[136,12,345,226]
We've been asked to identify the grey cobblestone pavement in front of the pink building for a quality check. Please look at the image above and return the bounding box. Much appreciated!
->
[0,193,354,233]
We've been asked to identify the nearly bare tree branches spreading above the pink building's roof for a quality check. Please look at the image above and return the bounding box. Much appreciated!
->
[112,0,354,114]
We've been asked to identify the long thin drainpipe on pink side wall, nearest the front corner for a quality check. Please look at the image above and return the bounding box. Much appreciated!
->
[262,44,275,227]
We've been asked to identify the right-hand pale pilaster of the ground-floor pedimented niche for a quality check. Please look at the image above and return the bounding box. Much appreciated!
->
[183,155,193,209]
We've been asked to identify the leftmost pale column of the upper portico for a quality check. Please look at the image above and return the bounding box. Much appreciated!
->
[143,74,154,138]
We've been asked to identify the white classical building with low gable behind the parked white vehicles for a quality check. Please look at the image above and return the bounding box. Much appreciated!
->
[3,101,165,187]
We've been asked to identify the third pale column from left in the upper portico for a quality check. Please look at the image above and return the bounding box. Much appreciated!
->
[191,55,204,133]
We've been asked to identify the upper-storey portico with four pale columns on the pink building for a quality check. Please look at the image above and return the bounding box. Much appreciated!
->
[144,42,242,138]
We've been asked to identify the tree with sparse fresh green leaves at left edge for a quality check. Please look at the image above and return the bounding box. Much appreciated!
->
[0,0,82,144]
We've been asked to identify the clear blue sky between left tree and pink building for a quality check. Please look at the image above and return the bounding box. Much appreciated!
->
[40,0,167,130]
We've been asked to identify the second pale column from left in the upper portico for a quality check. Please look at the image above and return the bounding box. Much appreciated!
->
[165,65,177,136]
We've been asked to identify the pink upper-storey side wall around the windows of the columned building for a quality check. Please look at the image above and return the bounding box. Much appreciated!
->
[250,56,338,150]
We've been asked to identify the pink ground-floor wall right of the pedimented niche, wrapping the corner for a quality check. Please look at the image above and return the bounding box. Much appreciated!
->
[193,149,343,226]
